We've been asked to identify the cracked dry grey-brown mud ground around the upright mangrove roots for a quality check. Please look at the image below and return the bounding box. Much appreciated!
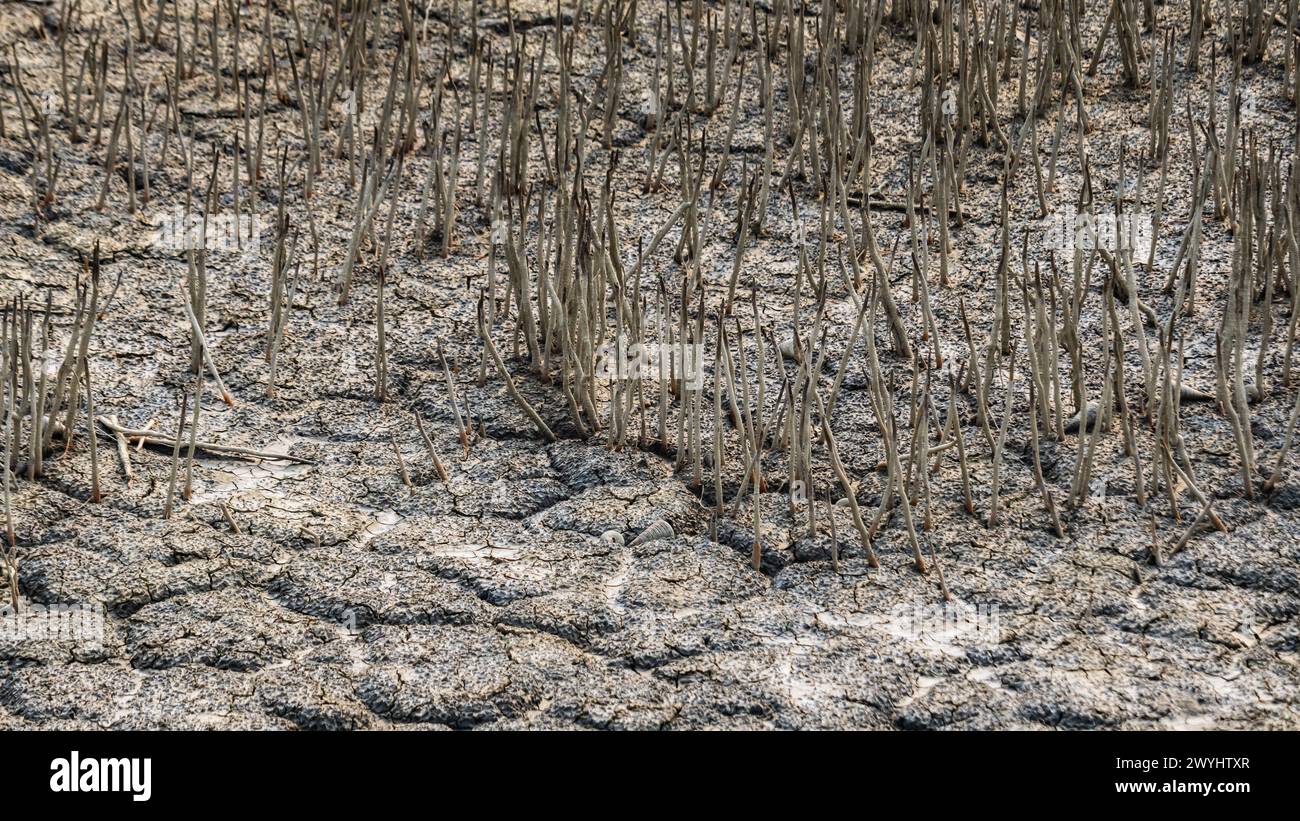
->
[0,1,1300,729]
